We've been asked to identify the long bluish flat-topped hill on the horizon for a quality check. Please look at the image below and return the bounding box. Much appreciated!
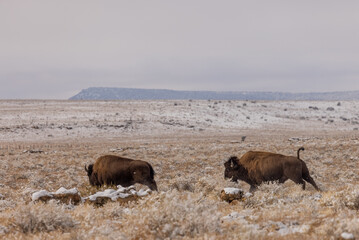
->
[69,87,359,101]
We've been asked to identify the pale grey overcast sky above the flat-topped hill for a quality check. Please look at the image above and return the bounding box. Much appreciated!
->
[0,0,359,99]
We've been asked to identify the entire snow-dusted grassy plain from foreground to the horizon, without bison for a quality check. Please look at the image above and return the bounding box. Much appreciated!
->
[0,100,359,239]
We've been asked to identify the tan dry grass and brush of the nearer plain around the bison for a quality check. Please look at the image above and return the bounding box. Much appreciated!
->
[0,100,359,239]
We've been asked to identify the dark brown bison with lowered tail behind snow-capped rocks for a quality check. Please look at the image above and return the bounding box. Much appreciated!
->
[85,155,157,191]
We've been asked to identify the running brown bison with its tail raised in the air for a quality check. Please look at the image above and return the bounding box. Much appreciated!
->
[224,147,320,191]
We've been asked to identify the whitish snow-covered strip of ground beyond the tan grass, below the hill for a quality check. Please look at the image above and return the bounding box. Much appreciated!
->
[0,100,359,141]
